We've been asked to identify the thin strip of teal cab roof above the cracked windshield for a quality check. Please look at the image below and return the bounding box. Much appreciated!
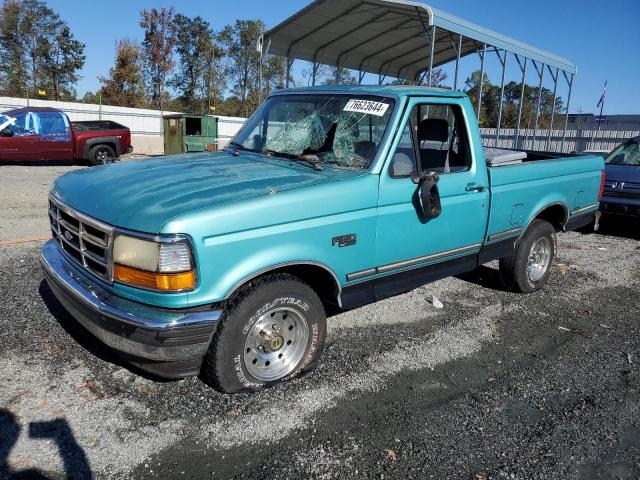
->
[274,85,466,98]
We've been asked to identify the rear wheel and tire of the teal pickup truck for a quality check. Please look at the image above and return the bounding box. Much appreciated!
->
[500,220,556,293]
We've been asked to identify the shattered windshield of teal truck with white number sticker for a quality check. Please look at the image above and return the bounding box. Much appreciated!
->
[231,95,394,168]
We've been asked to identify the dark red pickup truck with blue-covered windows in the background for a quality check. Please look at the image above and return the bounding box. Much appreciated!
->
[0,107,133,165]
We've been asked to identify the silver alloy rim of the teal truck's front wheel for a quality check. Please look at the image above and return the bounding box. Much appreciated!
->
[244,307,309,382]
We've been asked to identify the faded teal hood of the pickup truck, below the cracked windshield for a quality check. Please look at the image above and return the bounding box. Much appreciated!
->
[51,152,362,233]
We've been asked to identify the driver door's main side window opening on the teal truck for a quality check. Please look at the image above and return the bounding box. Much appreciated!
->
[412,104,471,174]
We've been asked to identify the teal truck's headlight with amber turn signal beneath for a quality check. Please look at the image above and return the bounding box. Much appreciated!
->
[113,234,196,291]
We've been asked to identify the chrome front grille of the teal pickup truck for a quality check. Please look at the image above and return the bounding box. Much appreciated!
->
[49,197,113,283]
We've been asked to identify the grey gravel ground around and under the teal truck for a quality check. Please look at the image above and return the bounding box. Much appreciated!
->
[0,163,640,480]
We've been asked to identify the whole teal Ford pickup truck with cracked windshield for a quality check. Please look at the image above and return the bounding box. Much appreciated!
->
[41,86,604,392]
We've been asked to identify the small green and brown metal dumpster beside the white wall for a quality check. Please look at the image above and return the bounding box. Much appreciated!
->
[163,114,218,155]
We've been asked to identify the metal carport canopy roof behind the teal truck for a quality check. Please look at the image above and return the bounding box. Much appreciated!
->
[264,0,576,80]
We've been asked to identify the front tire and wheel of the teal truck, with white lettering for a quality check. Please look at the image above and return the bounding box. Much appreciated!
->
[201,273,326,393]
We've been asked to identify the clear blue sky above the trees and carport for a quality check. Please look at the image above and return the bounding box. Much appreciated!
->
[47,0,640,114]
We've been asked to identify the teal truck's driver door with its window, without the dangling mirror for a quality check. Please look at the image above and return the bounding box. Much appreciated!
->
[375,98,489,297]
